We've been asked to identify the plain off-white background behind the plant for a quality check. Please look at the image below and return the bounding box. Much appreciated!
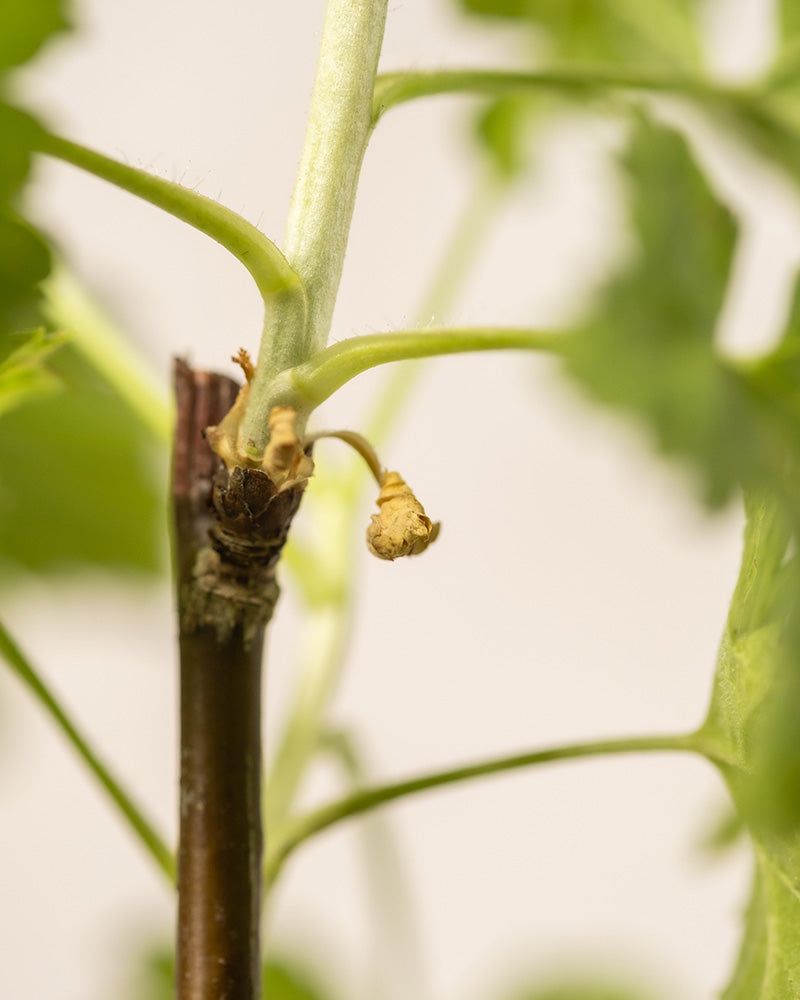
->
[0,0,797,1000]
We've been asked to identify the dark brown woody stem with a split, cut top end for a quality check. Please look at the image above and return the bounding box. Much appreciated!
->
[173,361,302,1000]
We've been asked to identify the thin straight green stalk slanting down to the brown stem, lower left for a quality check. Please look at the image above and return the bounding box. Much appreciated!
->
[0,624,175,884]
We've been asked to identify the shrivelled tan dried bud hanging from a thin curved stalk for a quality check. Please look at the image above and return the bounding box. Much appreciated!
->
[367,472,440,560]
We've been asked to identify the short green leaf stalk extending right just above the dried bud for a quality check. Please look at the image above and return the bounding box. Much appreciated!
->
[275,327,566,414]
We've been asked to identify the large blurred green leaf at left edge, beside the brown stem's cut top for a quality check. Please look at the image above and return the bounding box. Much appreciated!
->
[0,346,166,580]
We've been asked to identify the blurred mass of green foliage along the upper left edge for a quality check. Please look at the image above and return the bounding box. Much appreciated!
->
[0,0,164,581]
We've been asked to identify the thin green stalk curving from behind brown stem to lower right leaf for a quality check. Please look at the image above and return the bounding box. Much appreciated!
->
[266,733,709,883]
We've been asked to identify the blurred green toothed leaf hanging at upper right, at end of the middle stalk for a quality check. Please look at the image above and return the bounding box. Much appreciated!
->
[566,119,756,505]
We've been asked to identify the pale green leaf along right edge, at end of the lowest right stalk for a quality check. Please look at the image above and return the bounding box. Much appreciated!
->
[702,493,800,1000]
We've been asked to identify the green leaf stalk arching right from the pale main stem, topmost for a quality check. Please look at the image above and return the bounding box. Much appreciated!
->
[372,66,749,123]
